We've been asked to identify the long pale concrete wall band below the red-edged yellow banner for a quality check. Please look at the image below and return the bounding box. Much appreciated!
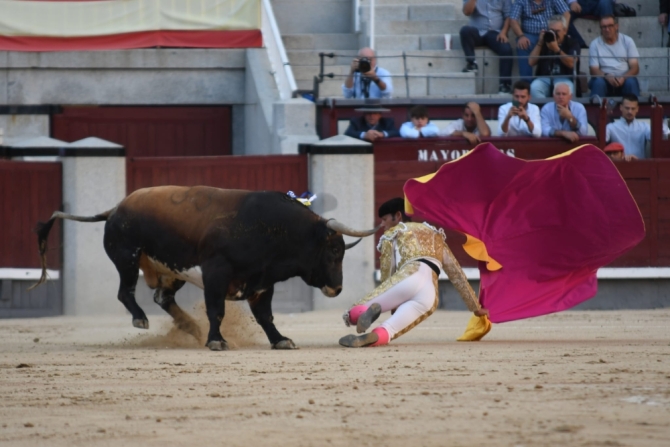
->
[0,49,246,105]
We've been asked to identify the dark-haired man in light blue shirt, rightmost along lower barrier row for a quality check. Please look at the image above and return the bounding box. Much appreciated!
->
[605,95,651,159]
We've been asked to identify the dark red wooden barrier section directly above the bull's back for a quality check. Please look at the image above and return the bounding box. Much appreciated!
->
[126,155,307,194]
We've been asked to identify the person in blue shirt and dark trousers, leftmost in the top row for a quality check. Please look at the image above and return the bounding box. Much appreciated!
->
[460,0,514,93]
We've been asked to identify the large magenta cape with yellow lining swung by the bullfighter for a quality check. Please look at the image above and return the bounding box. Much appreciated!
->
[404,142,644,323]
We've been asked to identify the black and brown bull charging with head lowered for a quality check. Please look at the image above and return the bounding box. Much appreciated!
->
[33,186,375,350]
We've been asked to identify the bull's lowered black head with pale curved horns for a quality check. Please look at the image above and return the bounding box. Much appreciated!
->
[305,219,379,298]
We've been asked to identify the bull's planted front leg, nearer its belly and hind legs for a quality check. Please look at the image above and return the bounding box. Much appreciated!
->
[201,258,232,351]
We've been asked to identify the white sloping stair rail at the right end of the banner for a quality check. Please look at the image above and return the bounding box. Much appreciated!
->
[261,0,298,100]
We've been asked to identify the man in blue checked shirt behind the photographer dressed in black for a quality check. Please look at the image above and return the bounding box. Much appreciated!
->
[510,0,570,82]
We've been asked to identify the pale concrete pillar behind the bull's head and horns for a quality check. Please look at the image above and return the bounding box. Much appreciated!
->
[309,154,375,312]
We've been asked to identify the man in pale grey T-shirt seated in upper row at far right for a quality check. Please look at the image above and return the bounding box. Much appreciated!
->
[589,16,640,98]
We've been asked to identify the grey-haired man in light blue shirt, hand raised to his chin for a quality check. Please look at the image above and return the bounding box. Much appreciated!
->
[540,82,589,143]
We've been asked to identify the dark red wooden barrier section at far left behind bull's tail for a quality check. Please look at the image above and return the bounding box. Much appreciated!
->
[0,160,63,269]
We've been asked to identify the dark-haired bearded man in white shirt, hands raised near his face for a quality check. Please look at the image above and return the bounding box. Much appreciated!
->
[498,81,542,137]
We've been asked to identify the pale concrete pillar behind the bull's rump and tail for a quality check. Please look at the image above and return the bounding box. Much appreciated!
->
[62,157,126,315]
